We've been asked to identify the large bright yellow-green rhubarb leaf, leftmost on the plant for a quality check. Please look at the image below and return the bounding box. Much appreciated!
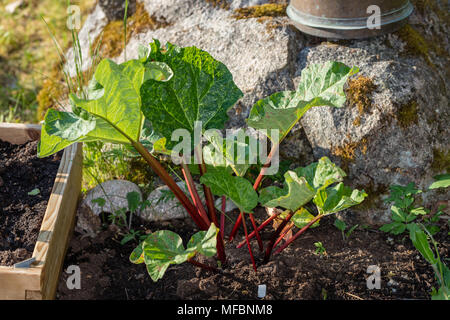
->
[38,59,171,157]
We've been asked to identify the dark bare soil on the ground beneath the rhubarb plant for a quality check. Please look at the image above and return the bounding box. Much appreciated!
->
[57,209,449,300]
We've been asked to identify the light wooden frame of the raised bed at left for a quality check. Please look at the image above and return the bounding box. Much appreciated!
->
[0,123,82,300]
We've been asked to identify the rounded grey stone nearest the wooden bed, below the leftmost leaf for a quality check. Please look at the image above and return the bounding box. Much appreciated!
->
[83,180,142,215]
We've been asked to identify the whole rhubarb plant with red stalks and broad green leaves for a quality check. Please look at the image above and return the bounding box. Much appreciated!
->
[38,40,366,281]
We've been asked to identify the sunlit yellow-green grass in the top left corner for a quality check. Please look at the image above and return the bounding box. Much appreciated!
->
[0,0,95,122]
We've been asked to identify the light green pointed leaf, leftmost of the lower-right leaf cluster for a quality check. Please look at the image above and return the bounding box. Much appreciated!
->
[259,171,316,211]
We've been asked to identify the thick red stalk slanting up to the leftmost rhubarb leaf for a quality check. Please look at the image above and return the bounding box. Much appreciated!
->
[130,140,209,230]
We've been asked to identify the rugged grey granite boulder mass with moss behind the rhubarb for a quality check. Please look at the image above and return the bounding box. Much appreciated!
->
[69,0,450,225]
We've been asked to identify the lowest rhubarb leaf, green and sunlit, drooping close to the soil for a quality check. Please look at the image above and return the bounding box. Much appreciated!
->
[130,223,219,282]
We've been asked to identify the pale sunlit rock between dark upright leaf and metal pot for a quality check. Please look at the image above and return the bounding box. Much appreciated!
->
[115,0,301,128]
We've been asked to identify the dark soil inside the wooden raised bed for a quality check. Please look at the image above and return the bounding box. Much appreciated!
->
[0,140,61,266]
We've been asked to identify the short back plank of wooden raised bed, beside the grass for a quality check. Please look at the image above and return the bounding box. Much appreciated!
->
[0,122,41,144]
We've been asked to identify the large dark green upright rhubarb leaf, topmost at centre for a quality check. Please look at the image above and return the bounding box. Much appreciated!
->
[141,40,243,149]
